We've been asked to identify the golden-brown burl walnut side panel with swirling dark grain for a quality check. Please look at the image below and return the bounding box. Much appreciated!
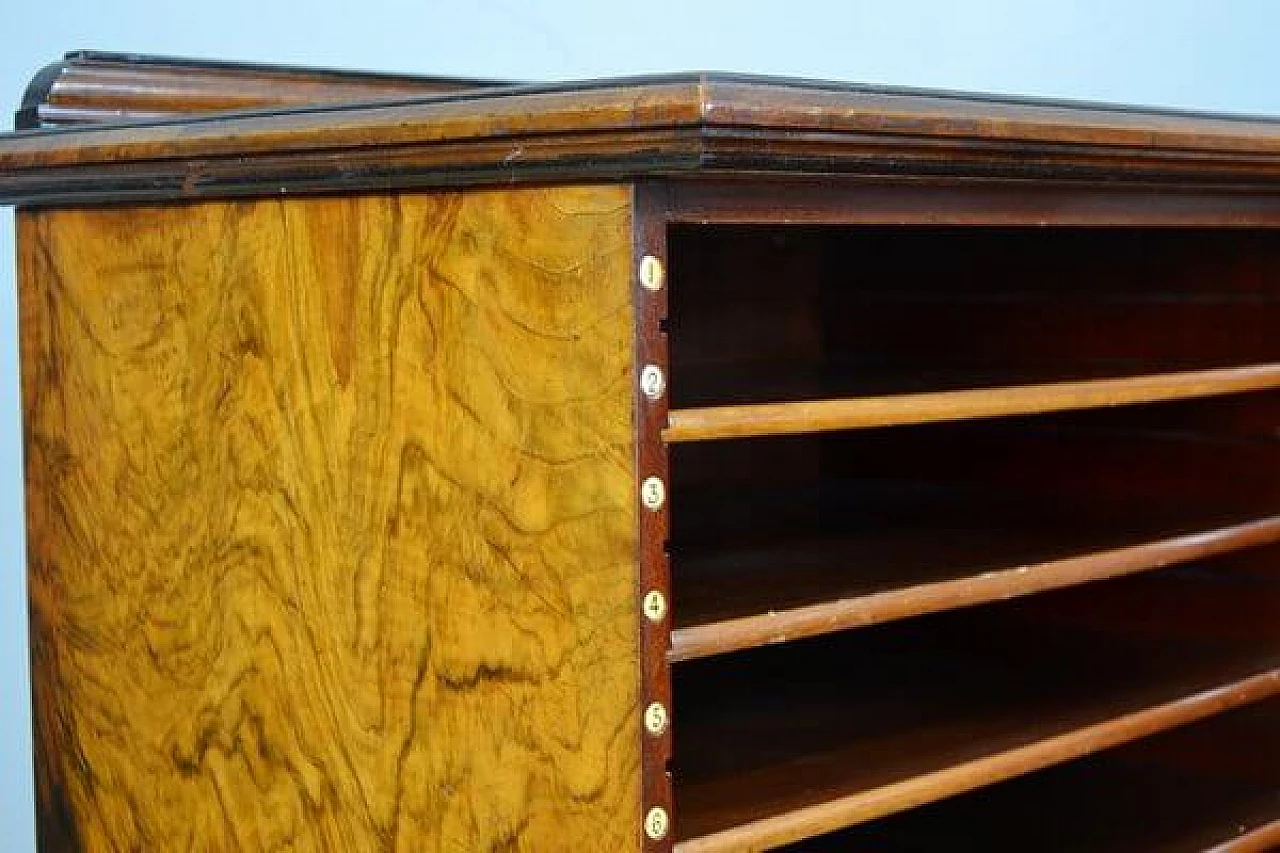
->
[19,187,641,853]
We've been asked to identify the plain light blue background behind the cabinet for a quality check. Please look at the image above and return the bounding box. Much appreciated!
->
[0,0,1280,853]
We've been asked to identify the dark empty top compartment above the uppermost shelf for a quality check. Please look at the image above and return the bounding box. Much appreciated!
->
[671,227,1280,406]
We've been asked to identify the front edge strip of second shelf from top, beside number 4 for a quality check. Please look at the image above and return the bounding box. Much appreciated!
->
[668,516,1280,662]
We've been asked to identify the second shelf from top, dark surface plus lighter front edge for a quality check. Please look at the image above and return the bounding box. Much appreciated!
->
[668,515,1280,662]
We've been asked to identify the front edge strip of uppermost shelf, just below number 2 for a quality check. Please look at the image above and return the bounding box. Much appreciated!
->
[663,364,1280,442]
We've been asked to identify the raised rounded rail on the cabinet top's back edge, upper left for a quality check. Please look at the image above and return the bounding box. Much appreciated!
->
[14,50,511,129]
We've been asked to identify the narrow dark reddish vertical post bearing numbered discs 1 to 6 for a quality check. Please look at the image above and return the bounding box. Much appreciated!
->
[631,183,676,852]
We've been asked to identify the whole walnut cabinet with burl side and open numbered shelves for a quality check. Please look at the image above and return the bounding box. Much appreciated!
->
[0,54,1280,853]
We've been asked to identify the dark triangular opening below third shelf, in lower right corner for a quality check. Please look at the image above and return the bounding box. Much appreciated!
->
[785,699,1280,853]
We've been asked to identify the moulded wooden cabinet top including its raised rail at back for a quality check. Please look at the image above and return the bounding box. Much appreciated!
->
[0,54,1280,204]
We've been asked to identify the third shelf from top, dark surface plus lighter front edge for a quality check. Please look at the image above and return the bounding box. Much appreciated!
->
[673,574,1280,853]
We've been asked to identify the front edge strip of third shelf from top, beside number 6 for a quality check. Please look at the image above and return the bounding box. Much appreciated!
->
[675,669,1280,853]
